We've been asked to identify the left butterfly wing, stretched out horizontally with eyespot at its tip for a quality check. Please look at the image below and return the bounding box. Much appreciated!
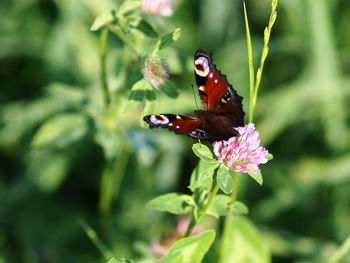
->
[143,114,209,140]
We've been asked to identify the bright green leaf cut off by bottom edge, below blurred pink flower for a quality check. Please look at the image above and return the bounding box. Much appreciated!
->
[155,230,215,263]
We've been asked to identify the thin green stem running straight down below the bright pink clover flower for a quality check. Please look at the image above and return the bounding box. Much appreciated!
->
[219,173,241,258]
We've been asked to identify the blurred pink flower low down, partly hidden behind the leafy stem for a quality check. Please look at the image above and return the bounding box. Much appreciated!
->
[152,218,202,258]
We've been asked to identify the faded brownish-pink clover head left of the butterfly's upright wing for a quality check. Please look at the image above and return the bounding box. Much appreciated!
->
[142,58,169,87]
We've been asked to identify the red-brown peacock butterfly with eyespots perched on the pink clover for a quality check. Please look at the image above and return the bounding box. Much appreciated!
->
[143,50,245,142]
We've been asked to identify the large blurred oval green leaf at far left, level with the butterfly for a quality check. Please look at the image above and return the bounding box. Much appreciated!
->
[31,113,87,151]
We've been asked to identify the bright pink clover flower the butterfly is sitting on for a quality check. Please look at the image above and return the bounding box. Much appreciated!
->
[213,123,268,174]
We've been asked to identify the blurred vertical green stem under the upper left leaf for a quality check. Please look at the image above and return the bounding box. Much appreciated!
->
[100,27,110,108]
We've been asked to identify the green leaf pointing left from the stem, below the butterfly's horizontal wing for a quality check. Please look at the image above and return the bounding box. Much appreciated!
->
[146,193,194,215]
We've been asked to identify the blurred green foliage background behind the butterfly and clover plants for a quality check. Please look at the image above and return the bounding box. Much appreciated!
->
[0,0,350,263]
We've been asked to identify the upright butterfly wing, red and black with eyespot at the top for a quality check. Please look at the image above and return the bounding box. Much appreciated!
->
[194,50,244,127]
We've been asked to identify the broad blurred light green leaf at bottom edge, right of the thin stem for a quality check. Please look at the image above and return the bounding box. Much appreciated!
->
[219,216,271,263]
